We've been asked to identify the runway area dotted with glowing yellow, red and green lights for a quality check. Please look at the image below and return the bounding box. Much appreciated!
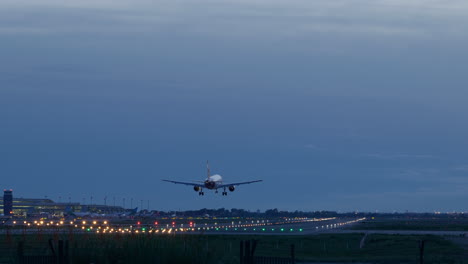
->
[0,217,365,235]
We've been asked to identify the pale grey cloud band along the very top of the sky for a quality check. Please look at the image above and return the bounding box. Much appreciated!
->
[0,0,468,38]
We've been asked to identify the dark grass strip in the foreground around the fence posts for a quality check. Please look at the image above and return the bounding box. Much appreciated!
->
[0,234,468,264]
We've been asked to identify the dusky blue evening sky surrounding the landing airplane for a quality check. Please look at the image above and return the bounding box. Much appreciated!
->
[0,0,468,212]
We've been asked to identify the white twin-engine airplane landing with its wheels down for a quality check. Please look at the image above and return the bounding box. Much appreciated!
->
[163,161,262,195]
